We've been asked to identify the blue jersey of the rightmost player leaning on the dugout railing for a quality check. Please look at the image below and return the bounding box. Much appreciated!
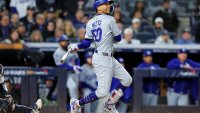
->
[167,58,200,94]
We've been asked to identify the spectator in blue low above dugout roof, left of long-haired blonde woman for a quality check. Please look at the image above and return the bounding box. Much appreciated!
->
[46,29,64,42]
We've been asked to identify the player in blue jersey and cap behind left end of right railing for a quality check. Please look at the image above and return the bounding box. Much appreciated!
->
[138,50,160,106]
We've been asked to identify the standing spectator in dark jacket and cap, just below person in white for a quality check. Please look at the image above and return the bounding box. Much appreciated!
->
[20,6,35,36]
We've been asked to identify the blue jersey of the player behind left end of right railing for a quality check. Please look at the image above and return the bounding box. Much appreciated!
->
[138,62,160,94]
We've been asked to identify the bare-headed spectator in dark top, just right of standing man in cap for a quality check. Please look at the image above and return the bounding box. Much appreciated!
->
[31,14,45,33]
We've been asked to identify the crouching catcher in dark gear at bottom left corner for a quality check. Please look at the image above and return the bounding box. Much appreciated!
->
[0,64,42,113]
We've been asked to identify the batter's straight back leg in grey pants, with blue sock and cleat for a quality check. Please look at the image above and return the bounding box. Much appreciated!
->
[70,54,113,113]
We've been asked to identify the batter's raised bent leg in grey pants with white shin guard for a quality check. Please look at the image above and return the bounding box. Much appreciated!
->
[105,58,132,113]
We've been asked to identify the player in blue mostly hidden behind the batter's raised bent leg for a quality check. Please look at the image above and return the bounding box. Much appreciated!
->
[110,58,133,113]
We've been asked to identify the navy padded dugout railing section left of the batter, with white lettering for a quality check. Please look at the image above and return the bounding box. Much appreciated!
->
[4,66,67,113]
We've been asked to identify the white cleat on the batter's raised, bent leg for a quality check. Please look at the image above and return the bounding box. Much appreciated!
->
[104,101,119,113]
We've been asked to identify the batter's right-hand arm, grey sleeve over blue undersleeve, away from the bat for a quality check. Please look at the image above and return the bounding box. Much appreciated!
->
[110,18,122,42]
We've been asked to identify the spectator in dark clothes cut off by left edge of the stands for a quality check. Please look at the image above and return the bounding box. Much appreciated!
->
[0,15,11,41]
